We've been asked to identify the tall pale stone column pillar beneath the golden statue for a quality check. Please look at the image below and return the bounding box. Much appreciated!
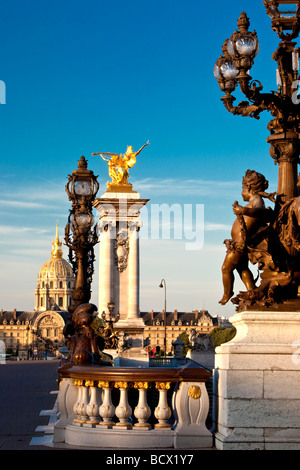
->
[94,189,148,356]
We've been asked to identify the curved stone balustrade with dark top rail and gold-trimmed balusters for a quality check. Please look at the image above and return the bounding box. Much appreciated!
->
[54,363,212,449]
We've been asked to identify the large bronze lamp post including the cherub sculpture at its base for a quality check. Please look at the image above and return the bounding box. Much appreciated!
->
[214,0,300,309]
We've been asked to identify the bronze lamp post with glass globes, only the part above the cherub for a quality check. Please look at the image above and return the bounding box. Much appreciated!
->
[214,0,300,206]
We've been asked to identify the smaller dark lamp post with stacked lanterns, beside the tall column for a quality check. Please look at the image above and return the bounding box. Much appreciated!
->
[65,156,99,313]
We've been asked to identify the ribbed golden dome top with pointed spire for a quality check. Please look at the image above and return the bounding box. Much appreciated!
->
[39,225,74,279]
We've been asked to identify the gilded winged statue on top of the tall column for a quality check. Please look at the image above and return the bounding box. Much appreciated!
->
[92,140,150,188]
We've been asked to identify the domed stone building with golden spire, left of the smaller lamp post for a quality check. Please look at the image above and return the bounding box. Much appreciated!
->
[0,227,75,359]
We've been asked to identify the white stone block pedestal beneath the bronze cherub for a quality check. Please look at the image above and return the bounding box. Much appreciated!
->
[214,311,300,450]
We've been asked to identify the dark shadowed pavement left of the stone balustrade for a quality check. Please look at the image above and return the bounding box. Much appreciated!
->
[0,360,59,450]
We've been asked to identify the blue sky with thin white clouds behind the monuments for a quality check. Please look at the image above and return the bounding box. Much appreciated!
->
[0,0,288,316]
